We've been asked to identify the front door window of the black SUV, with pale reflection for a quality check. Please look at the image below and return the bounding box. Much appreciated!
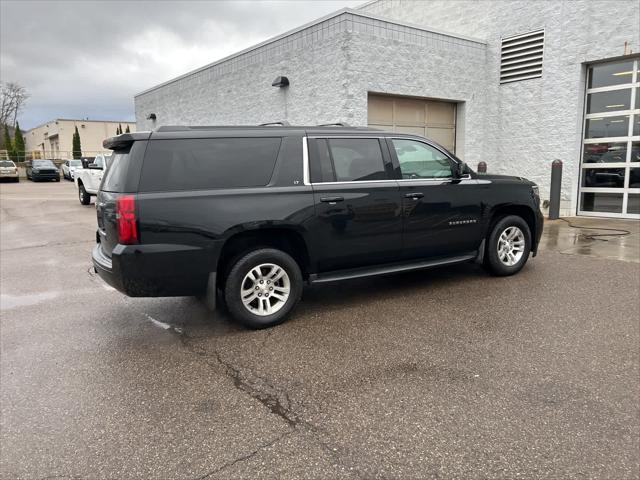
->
[393,139,452,179]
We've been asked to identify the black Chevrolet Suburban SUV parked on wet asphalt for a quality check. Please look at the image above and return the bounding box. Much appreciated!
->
[93,126,543,328]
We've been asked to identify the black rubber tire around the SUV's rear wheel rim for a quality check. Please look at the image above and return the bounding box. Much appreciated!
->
[224,248,303,329]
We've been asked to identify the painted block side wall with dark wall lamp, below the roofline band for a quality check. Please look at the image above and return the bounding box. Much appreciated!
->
[135,32,347,129]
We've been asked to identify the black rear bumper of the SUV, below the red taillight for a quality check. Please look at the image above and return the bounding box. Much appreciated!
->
[92,243,216,297]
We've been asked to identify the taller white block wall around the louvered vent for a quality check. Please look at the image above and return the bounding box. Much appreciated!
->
[361,0,640,213]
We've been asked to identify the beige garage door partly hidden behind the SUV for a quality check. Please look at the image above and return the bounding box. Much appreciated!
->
[368,94,456,152]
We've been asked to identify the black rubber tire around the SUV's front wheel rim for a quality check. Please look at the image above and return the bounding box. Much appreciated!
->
[484,215,531,277]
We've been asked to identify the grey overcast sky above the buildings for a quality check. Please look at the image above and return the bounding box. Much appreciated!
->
[0,0,364,129]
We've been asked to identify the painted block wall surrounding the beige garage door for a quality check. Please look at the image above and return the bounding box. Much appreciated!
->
[344,32,486,164]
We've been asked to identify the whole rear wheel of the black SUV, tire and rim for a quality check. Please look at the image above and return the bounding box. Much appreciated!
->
[224,248,302,328]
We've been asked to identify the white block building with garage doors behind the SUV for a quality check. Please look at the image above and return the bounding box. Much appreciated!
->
[135,0,640,218]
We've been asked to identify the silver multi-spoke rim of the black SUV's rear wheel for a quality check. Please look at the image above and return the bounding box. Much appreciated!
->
[240,263,291,317]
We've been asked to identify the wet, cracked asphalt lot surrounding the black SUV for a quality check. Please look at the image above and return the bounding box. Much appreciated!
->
[0,182,640,479]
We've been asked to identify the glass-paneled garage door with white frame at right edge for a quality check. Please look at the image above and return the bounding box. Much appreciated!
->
[578,58,640,218]
